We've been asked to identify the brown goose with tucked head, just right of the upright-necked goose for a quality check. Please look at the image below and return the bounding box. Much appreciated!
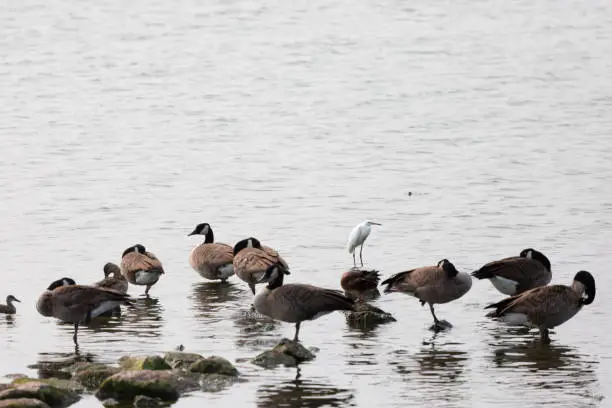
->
[234,237,289,294]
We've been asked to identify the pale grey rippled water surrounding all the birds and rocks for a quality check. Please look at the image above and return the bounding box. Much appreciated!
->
[0,0,612,407]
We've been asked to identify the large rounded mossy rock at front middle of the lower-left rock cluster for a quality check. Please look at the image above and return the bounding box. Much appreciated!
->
[96,370,179,402]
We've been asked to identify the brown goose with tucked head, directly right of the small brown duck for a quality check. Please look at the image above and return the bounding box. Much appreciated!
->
[121,244,164,296]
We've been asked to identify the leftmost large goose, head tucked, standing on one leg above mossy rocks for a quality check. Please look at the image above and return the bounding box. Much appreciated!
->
[36,278,130,346]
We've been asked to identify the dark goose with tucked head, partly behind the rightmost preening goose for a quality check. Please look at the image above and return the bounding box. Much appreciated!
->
[472,248,552,296]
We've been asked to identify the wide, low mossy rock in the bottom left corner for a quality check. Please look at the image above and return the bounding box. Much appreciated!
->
[0,378,81,408]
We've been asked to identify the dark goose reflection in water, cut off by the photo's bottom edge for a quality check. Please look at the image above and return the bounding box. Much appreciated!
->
[256,368,355,408]
